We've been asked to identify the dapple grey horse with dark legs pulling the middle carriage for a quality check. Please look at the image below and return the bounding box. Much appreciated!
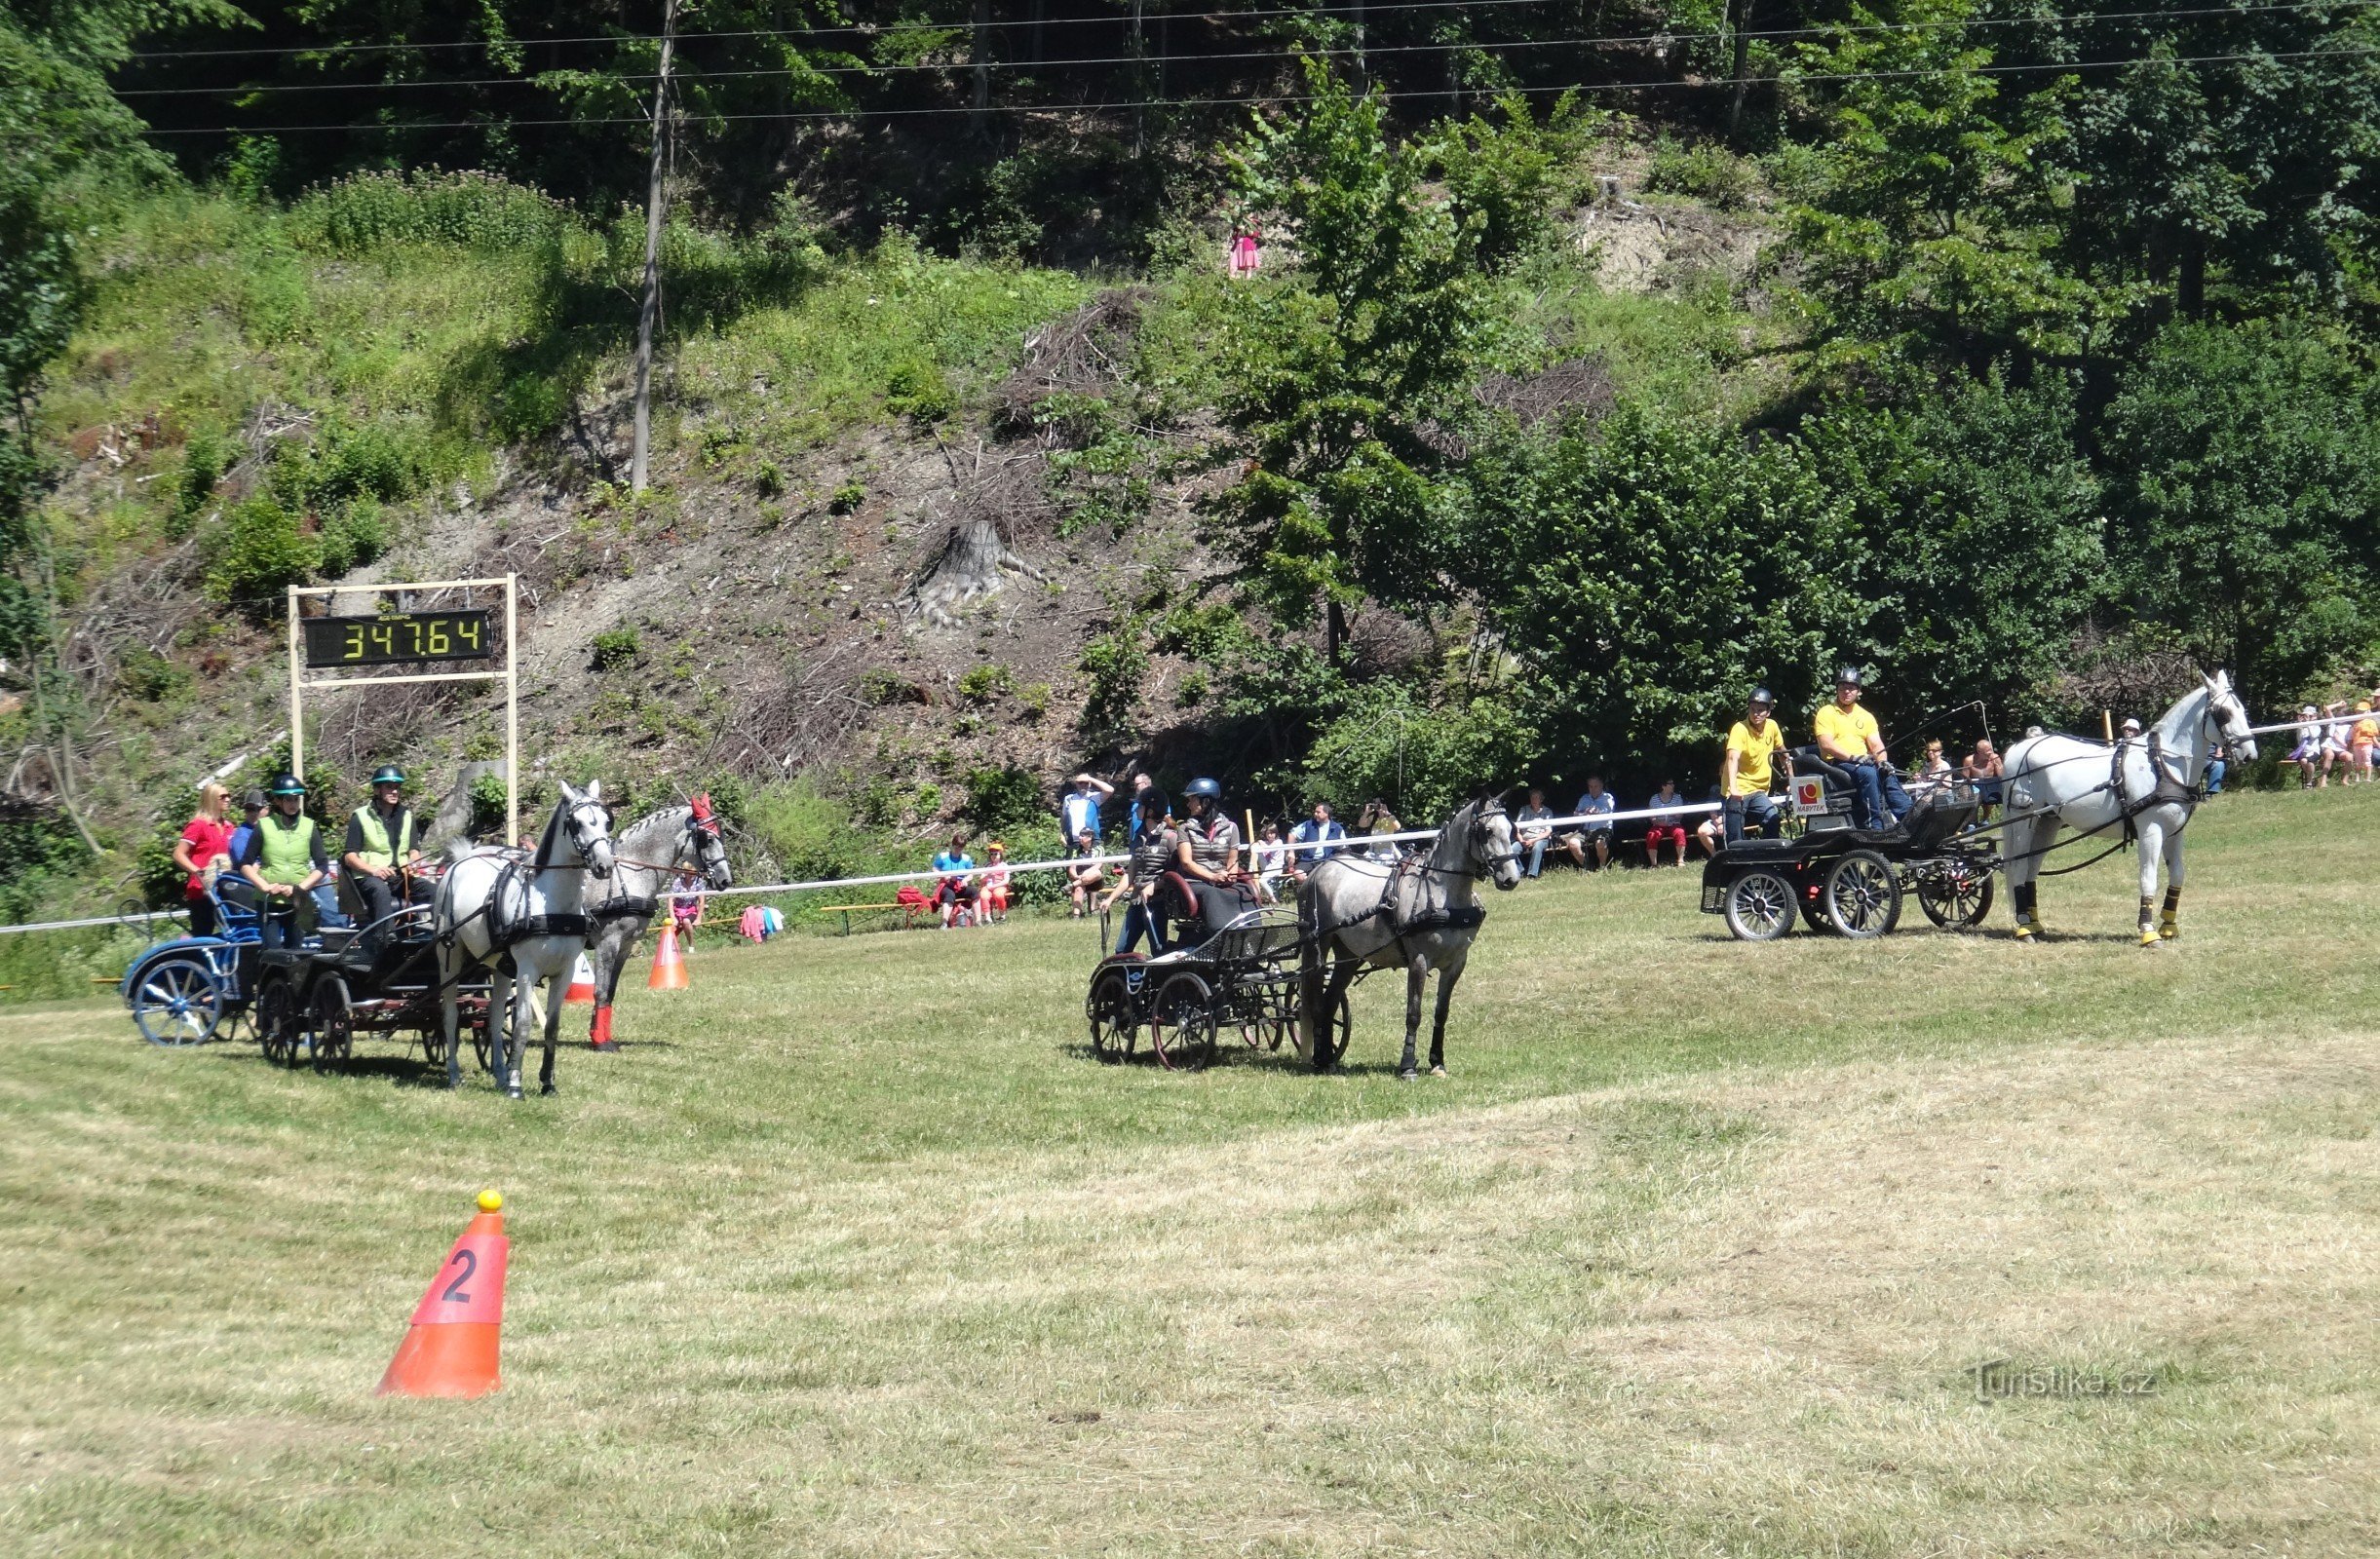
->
[1297,797,1520,1081]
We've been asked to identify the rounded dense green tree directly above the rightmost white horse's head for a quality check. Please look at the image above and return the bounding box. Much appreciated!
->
[2101,322,2380,709]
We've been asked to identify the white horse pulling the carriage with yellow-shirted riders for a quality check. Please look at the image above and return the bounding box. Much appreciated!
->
[2002,671,2256,947]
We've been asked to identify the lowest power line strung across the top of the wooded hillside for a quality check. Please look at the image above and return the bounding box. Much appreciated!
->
[147,48,2380,135]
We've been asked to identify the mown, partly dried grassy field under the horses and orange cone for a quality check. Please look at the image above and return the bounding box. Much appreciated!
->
[0,790,2380,1557]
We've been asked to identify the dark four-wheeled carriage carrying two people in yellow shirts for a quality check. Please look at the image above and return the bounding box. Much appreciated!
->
[1702,780,1999,942]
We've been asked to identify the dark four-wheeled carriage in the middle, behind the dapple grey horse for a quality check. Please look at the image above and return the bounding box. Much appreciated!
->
[1083,907,1347,1071]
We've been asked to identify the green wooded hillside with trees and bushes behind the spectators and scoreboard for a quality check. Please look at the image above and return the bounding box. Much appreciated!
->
[0,0,2380,919]
